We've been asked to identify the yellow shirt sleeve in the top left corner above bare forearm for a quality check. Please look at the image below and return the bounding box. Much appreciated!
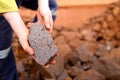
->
[0,0,18,13]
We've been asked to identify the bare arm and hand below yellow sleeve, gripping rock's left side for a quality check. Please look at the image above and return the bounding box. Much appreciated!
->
[3,12,33,55]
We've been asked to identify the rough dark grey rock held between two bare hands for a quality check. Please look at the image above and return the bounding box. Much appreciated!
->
[29,23,58,65]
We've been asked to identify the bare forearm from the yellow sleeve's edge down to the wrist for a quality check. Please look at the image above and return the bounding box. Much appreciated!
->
[3,12,28,37]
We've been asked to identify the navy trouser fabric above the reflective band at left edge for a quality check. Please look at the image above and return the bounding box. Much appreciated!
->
[0,16,13,50]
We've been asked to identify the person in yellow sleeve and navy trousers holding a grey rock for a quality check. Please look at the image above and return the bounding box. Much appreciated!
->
[0,0,53,80]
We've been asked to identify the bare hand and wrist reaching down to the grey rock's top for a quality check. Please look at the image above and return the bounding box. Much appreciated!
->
[37,0,53,33]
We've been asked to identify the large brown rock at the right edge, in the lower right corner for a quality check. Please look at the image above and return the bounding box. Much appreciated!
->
[92,48,120,80]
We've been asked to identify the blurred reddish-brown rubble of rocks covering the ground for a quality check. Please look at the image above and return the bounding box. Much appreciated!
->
[13,1,120,80]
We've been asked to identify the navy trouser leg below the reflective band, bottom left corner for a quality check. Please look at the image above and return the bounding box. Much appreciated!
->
[0,50,18,80]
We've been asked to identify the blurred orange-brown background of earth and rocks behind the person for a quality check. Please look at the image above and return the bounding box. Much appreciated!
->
[12,0,120,80]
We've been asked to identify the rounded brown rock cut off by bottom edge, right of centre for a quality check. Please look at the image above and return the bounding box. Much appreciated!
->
[76,69,105,80]
